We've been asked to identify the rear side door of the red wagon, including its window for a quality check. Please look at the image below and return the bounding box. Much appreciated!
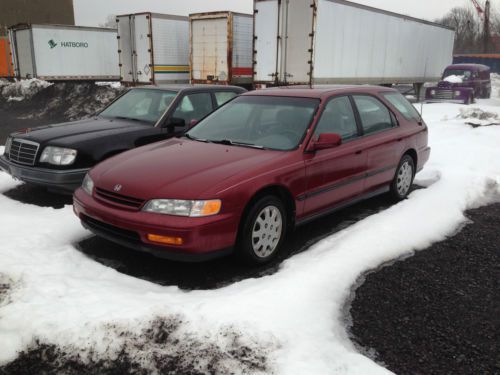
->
[353,95,404,192]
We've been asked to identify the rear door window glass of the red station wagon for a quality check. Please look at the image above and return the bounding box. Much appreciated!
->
[353,95,394,134]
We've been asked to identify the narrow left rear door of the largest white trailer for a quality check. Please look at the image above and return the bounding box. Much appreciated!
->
[254,0,281,82]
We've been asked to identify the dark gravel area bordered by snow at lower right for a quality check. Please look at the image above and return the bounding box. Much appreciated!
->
[350,203,500,374]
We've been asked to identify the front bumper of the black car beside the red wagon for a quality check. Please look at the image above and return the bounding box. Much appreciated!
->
[0,155,89,194]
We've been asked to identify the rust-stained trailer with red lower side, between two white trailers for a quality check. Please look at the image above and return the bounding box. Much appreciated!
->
[189,12,253,86]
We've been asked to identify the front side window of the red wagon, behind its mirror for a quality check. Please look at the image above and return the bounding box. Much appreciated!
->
[314,96,358,142]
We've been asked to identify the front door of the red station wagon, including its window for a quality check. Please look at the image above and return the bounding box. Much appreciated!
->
[304,96,366,216]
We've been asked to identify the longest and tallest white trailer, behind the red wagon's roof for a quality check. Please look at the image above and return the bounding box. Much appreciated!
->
[253,0,454,85]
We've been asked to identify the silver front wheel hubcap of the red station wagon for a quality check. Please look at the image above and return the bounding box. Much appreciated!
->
[252,206,283,258]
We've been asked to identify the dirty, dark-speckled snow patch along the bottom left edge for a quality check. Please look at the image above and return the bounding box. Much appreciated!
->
[0,317,275,375]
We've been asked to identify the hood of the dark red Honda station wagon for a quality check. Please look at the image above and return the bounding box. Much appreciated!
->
[91,138,287,200]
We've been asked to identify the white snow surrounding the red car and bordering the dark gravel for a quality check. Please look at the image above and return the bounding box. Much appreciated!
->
[0,93,500,375]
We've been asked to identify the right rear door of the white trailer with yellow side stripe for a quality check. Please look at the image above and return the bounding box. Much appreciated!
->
[133,14,153,83]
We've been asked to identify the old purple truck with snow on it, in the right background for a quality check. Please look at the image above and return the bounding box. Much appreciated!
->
[425,64,491,104]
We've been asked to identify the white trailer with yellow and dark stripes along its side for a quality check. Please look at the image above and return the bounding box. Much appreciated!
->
[116,13,189,84]
